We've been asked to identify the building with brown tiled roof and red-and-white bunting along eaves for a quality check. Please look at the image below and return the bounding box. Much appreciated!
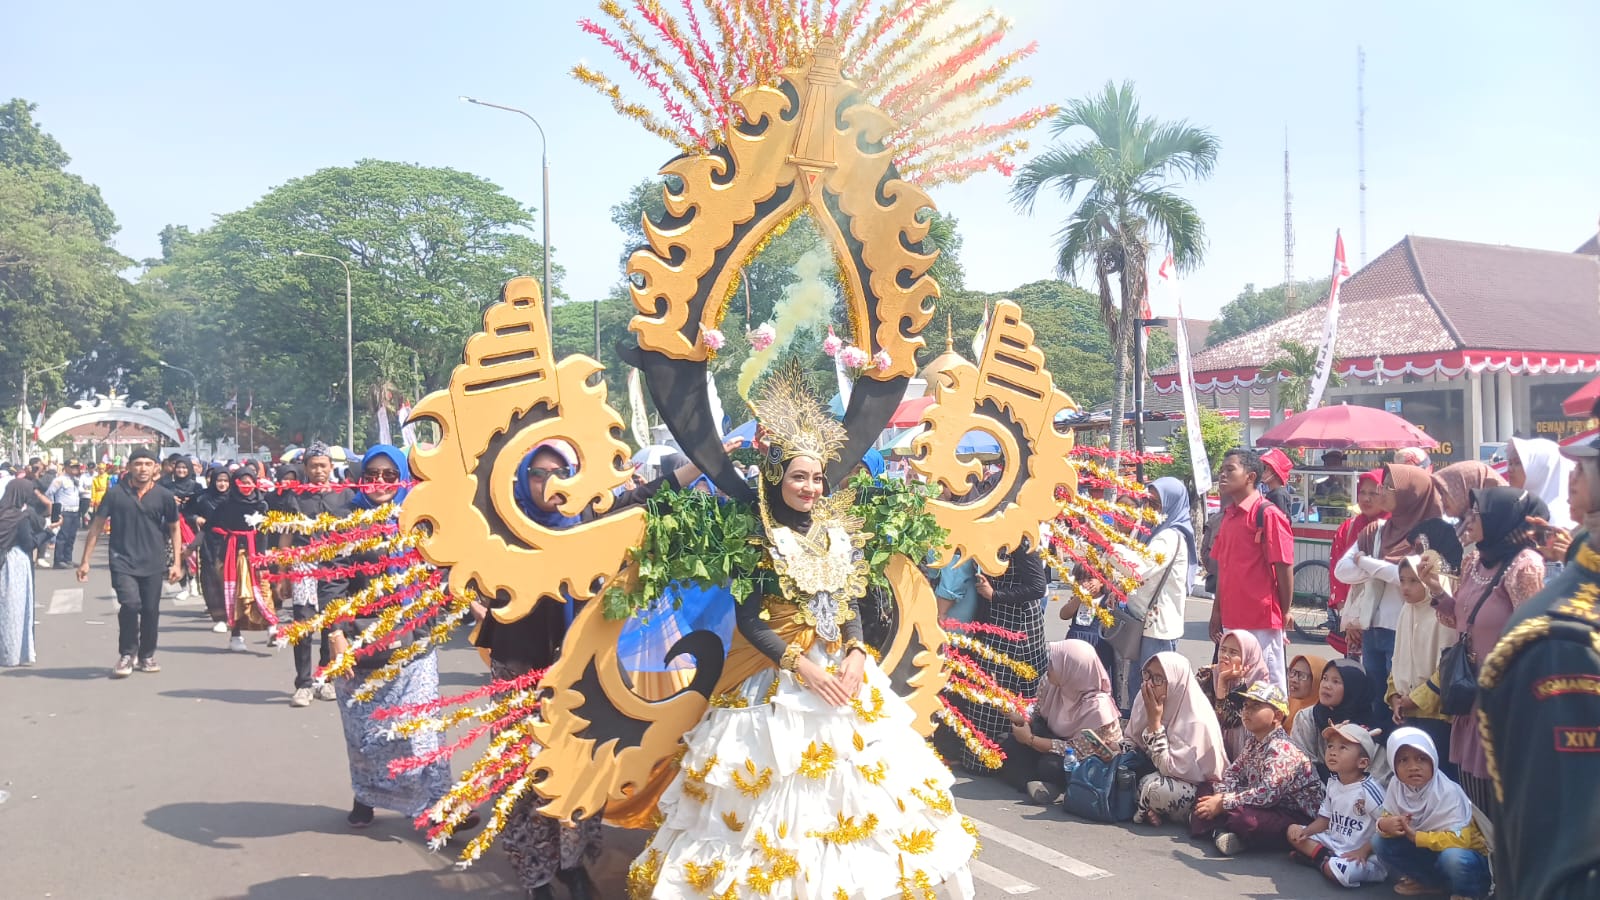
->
[1152,235,1600,460]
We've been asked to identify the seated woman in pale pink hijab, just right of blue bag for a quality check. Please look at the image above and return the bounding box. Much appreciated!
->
[1128,647,1228,825]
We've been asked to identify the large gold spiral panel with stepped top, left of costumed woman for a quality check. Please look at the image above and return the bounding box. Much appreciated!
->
[400,277,645,621]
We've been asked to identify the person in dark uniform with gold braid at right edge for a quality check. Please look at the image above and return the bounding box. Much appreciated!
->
[1478,404,1600,900]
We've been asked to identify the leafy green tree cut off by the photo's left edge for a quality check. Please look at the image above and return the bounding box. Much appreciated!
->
[0,99,131,431]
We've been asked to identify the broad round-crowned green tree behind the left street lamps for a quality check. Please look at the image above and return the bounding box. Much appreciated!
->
[146,160,562,444]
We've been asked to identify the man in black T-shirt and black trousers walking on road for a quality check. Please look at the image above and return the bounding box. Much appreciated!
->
[78,448,182,677]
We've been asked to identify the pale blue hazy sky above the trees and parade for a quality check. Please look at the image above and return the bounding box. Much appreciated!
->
[12,0,1600,317]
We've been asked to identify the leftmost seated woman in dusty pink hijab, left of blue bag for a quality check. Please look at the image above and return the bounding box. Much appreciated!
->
[1002,639,1122,806]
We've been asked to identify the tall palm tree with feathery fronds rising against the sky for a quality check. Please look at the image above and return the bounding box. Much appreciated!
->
[1011,82,1219,450]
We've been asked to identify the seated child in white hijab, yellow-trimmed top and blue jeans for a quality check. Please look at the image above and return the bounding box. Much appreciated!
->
[1373,727,1490,900]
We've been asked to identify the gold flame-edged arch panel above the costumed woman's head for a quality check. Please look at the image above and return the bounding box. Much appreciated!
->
[627,43,939,380]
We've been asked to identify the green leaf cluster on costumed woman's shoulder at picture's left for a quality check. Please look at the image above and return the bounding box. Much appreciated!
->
[603,485,765,620]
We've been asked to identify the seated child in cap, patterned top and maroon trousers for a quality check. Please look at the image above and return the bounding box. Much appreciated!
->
[1189,681,1325,857]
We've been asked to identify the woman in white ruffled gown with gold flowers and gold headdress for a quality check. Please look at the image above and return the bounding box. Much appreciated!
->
[629,370,976,900]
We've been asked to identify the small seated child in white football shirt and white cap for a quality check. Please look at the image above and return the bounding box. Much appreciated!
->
[1288,722,1389,887]
